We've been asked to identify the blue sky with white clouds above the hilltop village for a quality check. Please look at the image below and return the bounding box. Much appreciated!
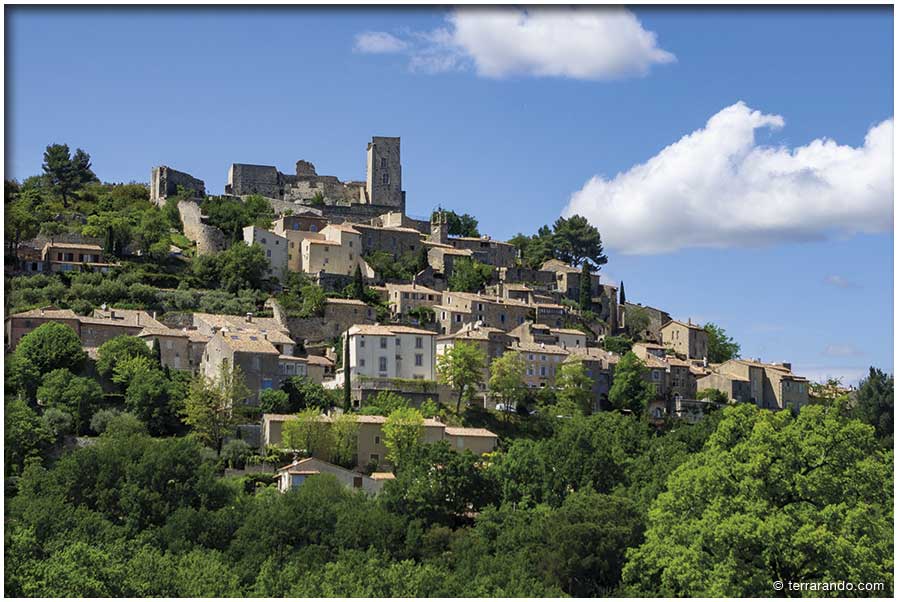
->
[5,6,894,382]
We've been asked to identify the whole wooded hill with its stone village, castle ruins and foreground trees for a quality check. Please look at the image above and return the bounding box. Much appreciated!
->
[4,137,893,598]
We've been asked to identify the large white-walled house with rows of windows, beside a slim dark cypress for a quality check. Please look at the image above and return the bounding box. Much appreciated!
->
[347,324,436,380]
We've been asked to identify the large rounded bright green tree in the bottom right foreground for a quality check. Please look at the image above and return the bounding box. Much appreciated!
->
[623,404,893,598]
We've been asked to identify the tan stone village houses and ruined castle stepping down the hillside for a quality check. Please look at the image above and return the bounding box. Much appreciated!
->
[6,137,809,486]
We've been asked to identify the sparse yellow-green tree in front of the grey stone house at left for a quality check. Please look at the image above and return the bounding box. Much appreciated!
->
[181,362,250,455]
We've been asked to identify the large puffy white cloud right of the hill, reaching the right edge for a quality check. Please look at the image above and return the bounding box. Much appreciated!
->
[563,101,893,254]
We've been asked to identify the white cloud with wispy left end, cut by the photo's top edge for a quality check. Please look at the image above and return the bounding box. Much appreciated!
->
[356,7,676,80]
